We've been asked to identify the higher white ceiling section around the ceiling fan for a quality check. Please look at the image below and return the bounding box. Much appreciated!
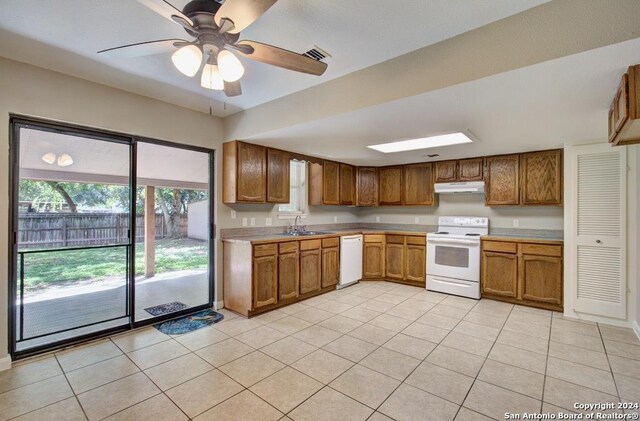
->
[0,0,548,116]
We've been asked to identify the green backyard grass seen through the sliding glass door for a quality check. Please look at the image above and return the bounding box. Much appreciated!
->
[25,238,208,289]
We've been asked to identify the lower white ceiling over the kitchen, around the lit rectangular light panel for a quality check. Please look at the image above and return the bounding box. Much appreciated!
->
[250,38,640,165]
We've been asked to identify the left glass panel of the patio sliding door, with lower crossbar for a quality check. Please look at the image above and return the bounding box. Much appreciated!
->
[11,124,132,352]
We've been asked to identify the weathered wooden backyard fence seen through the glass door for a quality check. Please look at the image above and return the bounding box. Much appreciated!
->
[18,213,187,249]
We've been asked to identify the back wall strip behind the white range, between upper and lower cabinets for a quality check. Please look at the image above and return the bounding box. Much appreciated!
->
[359,194,563,230]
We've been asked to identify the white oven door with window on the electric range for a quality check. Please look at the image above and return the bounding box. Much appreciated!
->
[427,237,480,282]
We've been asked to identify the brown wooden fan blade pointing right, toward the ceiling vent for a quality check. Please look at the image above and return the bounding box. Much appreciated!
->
[234,41,327,76]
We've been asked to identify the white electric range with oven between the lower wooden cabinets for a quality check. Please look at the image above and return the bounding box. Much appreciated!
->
[427,216,489,299]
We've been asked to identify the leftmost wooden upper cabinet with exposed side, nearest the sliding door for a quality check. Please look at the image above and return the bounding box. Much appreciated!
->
[222,141,267,203]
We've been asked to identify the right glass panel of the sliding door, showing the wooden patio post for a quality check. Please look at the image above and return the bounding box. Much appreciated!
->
[134,142,211,322]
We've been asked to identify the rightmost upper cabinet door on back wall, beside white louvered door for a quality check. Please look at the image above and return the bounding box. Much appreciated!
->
[520,149,562,206]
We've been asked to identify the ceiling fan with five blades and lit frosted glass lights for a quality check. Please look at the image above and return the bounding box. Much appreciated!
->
[98,0,327,97]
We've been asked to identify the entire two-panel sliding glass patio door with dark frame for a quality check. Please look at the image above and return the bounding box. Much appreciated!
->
[9,117,213,356]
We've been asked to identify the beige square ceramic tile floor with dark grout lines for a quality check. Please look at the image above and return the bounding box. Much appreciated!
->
[0,282,640,421]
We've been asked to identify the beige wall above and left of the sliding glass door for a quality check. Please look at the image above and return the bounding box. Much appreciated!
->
[0,58,222,358]
